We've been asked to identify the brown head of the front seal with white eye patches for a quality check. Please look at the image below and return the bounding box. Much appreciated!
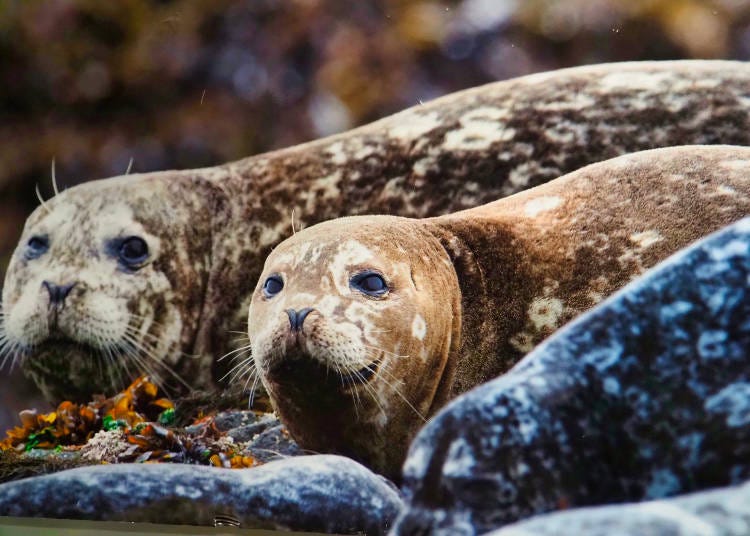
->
[249,216,460,474]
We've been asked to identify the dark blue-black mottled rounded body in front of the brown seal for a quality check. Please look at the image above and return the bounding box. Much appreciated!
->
[395,219,750,535]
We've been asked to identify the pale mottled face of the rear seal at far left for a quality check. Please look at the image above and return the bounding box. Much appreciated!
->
[1,179,213,400]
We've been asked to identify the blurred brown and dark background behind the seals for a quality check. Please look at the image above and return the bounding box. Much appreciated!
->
[0,0,750,435]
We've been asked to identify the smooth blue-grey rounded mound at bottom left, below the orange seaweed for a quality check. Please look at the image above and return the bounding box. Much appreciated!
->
[0,456,401,534]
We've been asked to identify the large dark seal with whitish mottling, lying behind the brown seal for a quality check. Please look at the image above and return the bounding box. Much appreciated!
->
[0,61,750,401]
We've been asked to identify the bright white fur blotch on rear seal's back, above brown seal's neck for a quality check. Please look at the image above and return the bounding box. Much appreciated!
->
[443,107,516,151]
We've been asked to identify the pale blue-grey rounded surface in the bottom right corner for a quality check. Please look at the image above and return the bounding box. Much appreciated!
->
[487,482,750,536]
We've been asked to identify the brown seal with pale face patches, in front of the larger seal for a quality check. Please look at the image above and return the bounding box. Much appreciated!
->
[248,146,750,478]
